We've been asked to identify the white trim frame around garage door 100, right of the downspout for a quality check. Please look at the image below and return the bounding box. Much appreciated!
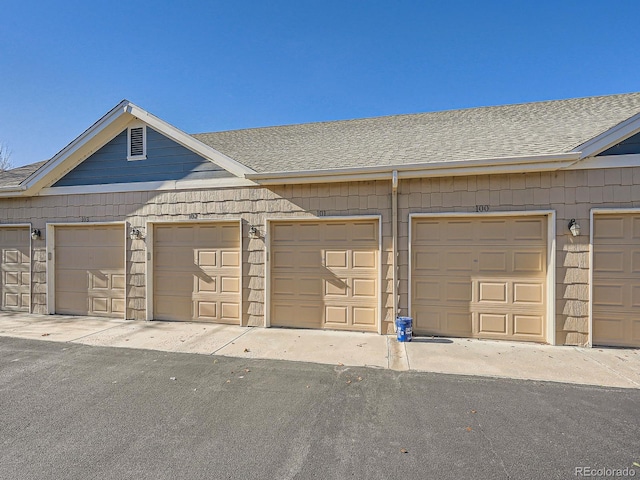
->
[407,210,556,345]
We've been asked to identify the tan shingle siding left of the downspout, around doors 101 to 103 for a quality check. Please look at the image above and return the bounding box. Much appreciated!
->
[8,181,393,332]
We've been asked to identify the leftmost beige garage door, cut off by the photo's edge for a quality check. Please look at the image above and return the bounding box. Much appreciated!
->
[0,227,31,312]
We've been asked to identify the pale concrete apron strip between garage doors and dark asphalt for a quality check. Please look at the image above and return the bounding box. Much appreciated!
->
[0,312,640,389]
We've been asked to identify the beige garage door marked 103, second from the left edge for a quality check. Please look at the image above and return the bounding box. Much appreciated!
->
[55,225,125,318]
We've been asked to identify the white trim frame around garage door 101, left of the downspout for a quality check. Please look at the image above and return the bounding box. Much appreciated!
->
[264,214,383,335]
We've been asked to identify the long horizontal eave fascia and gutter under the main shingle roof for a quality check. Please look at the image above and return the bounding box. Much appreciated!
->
[246,152,580,185]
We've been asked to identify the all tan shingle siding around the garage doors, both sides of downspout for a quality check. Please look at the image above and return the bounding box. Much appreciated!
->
[0,167,640,345]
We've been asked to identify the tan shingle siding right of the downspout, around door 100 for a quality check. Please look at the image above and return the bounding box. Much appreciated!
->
[398,167,640,345]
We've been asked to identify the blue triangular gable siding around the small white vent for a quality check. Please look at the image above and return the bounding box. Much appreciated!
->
[53,127,234,187]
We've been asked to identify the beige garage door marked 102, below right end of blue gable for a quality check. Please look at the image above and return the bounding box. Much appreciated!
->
[153,222,241,325]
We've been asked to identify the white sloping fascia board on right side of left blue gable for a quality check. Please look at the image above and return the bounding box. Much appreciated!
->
[126,103,255,177]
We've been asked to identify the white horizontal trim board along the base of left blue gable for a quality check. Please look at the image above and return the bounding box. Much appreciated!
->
[38,177,259,196]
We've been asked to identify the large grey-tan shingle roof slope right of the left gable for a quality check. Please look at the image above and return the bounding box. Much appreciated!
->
[193,93,640,173]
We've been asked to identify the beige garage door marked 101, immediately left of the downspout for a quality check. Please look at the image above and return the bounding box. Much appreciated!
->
[270,219,379,332]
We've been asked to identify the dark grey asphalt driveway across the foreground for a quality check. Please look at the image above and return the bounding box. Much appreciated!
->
[0,337,640,480]
